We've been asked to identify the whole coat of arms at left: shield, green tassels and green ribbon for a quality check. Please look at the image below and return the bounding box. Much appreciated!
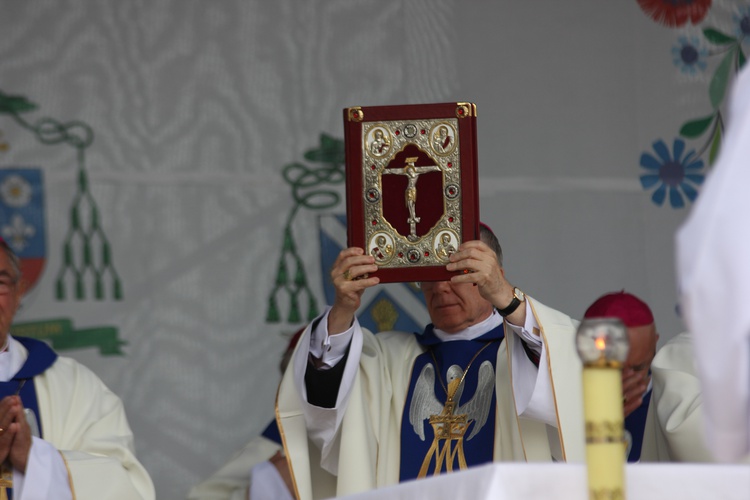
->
[0,91,125,355]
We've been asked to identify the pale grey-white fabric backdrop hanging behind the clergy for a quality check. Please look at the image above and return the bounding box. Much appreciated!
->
[0,0,748,499]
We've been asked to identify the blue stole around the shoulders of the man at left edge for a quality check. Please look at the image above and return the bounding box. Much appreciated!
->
[0,337,57,437]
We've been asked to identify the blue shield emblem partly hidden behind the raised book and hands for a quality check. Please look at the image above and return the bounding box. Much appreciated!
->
[318,214,430,333]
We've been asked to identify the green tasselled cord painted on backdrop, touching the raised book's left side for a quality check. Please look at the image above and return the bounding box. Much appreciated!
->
[266,134,345,323]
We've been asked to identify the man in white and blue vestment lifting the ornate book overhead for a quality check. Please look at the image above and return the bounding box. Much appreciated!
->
[277,225,585,500]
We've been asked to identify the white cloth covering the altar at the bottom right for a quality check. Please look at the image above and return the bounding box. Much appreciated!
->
[342,463,750,500]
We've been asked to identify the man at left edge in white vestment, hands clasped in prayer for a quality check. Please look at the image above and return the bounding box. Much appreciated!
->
[0,239,155,500]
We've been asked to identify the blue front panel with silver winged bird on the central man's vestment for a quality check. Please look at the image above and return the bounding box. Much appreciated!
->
[399,324,505,481]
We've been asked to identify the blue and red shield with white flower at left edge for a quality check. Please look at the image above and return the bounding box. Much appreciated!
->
[0,168,46,288]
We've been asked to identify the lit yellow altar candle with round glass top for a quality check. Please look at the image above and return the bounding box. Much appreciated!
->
[576,318,628,500]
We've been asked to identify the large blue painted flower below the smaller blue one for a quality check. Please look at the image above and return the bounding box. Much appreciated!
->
[640,139,706,208]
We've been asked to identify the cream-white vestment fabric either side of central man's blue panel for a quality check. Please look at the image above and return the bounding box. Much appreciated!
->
[277,296,585,500]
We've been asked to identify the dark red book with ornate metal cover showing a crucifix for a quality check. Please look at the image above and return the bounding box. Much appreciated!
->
[344,102,479,283]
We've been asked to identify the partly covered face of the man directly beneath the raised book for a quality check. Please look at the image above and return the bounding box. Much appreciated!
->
[422,281,492,333]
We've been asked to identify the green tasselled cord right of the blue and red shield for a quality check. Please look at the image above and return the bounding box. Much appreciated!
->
[0,91,123,300]
